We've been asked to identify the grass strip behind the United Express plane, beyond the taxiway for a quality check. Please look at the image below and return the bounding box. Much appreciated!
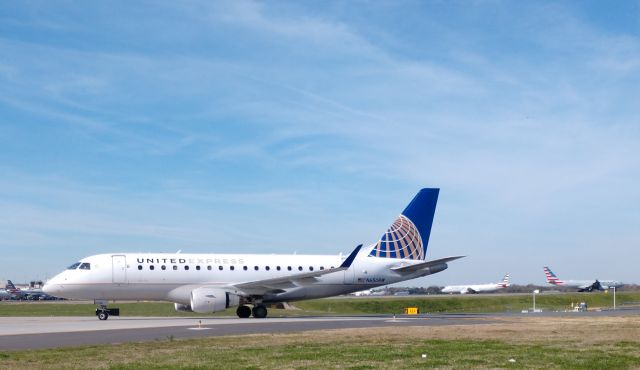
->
[0,292,640,317]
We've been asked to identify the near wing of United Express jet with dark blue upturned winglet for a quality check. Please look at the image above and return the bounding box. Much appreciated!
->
[230,244,362,295]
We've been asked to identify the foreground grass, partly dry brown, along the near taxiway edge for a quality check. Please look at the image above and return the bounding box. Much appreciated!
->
[0,317,640,369]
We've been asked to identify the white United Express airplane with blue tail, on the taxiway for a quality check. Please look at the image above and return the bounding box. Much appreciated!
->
[43,189,464,320]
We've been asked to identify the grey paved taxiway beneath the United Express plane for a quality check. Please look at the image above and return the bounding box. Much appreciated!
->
[0,310,640,350]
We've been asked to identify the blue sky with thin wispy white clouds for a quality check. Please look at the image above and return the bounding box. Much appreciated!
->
[0,1,640,285]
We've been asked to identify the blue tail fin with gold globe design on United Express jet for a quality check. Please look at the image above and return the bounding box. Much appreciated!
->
[369,189,440,260]
